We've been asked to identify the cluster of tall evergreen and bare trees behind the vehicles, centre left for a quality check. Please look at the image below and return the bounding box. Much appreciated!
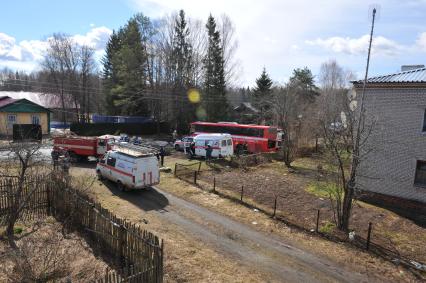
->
[102,10,236,132]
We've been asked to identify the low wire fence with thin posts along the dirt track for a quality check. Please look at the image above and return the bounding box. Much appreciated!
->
[175,162,426,278]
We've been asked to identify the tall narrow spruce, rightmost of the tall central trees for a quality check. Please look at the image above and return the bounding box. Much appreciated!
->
[203,15,229,122]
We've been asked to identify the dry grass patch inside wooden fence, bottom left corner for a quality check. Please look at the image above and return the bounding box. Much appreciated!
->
[0,218,107,282]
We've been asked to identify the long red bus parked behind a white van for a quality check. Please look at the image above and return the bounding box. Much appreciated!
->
[191,122,282,153]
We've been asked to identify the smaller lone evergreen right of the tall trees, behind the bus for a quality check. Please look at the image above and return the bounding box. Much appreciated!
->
[254,68,273,123]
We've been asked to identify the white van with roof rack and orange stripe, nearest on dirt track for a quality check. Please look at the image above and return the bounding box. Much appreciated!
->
[96,145,160,191]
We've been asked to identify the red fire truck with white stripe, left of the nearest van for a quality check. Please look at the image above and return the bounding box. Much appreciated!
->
[53,135,114,161]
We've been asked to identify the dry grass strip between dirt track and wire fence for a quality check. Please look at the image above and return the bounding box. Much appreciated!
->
[159,156,424,282]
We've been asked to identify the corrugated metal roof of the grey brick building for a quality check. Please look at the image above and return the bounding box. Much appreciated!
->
[353,68,426,84]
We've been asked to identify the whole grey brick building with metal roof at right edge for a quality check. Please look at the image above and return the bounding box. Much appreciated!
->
[353,67,426,219]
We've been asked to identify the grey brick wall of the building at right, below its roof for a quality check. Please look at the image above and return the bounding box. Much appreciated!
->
[357,86,426,204]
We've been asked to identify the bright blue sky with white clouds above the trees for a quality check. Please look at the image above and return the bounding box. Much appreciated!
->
[0,0,426,86]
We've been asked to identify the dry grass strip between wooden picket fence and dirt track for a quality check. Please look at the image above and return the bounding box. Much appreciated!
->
[72,168,271,282]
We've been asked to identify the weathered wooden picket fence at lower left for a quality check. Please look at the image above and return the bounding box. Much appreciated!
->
[0,175,163,283]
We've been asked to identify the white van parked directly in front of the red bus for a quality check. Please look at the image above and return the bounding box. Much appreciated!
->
[194,134,234,157]
